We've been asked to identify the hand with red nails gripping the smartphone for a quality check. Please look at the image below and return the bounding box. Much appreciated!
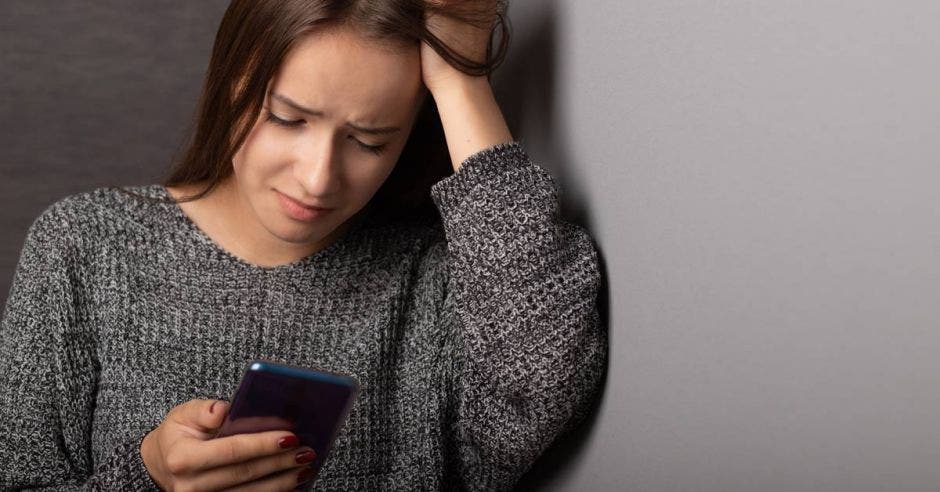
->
[140,400,316,492]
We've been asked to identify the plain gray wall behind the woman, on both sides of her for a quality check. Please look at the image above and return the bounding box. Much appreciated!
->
[0,0,940,492]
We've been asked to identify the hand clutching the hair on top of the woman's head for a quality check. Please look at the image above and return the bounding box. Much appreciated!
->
[421,0,498,93]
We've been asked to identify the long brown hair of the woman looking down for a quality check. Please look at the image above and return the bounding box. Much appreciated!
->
[115,0,510,223]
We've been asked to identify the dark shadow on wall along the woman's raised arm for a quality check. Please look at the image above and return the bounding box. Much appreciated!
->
[493,1,610,491]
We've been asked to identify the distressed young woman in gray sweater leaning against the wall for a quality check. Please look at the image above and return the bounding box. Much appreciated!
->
[0,0,606,490]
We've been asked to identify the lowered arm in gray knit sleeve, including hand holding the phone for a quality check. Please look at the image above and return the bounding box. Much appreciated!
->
[0,200,313,491]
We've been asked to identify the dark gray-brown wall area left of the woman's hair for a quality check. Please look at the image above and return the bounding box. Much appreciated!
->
[0,0,228,301]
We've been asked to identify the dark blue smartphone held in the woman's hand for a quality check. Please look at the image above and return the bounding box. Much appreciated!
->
[213,360,359,488]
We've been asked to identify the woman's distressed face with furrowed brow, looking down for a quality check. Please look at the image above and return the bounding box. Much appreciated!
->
[230,28,424,257]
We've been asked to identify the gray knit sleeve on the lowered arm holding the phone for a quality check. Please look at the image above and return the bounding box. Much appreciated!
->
[0,202,156,490]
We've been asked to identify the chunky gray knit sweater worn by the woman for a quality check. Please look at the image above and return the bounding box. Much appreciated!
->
[0,142,607,490]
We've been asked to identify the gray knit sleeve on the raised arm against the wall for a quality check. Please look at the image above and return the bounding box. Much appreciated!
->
[431,142,607,490]
